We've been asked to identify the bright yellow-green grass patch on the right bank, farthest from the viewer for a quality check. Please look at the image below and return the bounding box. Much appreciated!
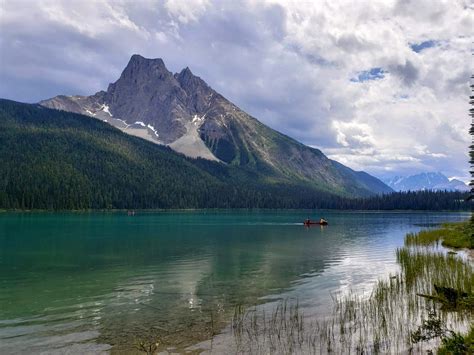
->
[405,221,474,249]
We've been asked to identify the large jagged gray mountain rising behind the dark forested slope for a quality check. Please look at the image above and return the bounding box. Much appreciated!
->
[40,55,393,196]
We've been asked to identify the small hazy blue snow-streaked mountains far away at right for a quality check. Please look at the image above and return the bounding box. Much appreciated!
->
[383,172,469,191]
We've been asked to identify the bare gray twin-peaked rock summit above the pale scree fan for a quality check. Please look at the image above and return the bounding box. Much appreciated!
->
[40,54,213,144]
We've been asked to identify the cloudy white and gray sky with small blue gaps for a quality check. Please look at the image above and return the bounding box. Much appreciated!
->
[0,0,474,181]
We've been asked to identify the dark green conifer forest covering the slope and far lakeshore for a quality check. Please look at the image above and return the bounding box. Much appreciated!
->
[0,100,469,210]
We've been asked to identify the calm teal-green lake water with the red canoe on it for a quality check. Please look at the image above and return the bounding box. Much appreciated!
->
[0,211,470,354]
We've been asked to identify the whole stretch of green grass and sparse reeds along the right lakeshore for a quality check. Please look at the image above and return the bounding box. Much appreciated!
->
[228,227,474,354]
